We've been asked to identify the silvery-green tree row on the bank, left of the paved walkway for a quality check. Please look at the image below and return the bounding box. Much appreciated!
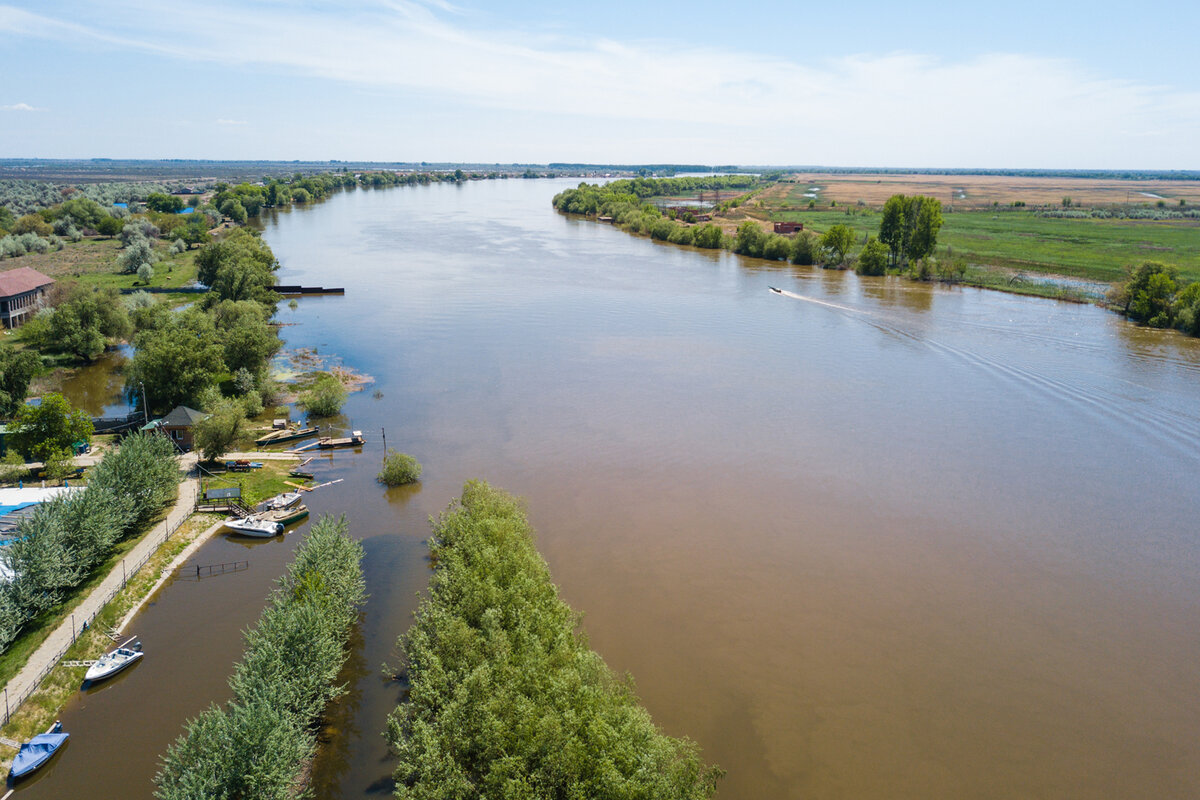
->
[0,433,180,651]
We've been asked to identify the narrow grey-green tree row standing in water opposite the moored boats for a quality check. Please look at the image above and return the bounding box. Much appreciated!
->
[155,517,366,800]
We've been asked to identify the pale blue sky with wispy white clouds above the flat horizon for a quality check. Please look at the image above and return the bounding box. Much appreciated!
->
[0,0,1200,169]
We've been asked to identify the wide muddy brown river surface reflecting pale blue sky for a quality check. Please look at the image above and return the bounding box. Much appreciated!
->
[20,180,1200,799]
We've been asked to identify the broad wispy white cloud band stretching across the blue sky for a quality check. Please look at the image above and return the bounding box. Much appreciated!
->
[0,0,1200,168]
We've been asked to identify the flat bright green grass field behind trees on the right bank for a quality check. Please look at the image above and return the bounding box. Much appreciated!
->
[764,207,1200,283]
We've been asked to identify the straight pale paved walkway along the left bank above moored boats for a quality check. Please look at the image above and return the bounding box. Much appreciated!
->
[0,453,197,718]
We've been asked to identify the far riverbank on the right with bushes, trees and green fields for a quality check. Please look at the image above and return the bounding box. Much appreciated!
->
[552,176,1200,335]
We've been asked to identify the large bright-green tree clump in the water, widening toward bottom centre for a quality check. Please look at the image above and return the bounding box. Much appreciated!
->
[385,481,724,800]
